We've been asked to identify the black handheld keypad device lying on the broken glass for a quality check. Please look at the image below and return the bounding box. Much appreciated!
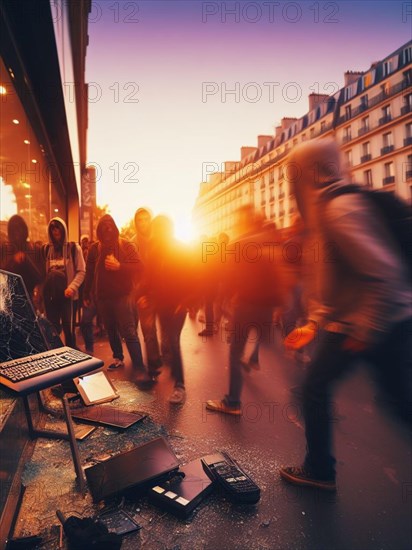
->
[202,451,260,504]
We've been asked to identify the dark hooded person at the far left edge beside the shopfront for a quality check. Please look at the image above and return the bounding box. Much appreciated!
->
[0,214,44,298]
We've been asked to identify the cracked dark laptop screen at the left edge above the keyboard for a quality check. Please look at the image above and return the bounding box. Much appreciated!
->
[0,270,48,363]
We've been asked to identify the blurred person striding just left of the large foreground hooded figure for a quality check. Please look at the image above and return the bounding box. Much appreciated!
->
[206,205,285,415]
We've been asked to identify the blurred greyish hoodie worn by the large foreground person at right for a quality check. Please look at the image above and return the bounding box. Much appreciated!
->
[287,138,412,344]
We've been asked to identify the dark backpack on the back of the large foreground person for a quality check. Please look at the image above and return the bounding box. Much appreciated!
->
[326,185,412,275]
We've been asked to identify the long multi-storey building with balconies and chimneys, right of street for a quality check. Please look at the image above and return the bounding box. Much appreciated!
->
[193,41,412,236]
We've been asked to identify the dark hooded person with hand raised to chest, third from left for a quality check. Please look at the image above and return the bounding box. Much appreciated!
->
[83,214,153,389]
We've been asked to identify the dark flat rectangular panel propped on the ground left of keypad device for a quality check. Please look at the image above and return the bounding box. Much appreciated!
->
[85,437,179,502]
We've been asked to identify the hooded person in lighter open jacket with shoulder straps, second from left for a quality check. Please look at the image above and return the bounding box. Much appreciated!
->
[43,217,85,348]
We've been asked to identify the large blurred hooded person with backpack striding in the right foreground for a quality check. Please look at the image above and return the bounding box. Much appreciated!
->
[280,138,412,491]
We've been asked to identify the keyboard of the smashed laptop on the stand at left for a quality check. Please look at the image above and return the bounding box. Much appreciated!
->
[0,347,91,382]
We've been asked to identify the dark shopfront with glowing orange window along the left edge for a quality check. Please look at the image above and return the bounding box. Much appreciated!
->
[0,0,91,241]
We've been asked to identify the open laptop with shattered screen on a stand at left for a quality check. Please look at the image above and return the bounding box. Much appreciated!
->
[0,270,103,395]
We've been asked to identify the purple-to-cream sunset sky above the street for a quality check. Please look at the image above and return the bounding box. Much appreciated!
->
[86,0,412,239]
